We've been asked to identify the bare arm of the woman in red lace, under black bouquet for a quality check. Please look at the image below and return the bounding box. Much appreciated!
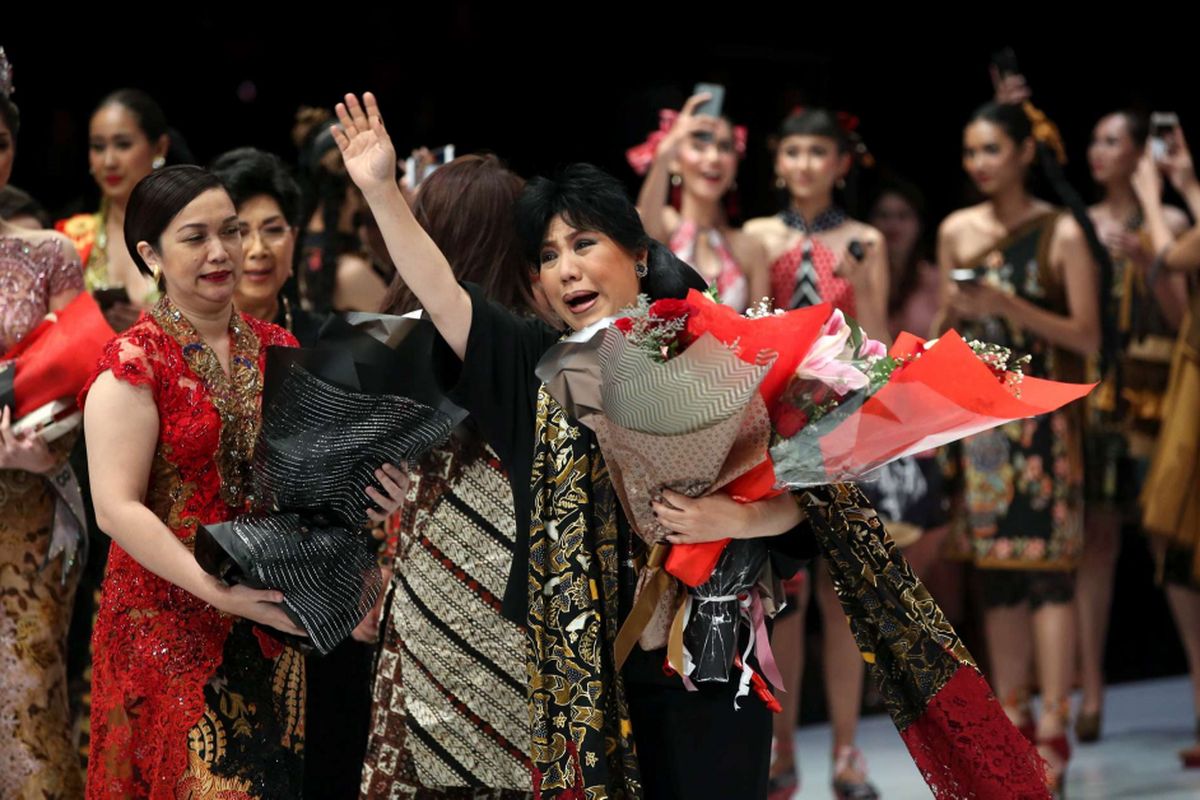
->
[84,372,304,634]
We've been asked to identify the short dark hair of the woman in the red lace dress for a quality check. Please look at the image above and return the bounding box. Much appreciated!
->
[125,164,224,275]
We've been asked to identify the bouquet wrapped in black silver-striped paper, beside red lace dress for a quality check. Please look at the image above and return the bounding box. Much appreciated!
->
[196,315,466,652]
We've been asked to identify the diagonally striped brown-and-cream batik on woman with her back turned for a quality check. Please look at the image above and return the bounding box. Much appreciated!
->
[362,438,530,800]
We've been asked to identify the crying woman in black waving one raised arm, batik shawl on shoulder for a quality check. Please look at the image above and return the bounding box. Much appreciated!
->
[337,94,809,798]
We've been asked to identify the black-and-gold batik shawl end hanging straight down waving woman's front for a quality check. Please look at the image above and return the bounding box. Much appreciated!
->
[527,387,642,800]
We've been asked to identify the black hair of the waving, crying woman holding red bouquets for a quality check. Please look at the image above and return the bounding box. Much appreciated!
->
[516,163,707,300]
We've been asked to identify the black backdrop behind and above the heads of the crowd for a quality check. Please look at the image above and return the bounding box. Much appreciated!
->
[7,14,1200,708]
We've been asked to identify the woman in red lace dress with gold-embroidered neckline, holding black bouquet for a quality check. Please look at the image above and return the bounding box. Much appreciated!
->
[84,167,402,799]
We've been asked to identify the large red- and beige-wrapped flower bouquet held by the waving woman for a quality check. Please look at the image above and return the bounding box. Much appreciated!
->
[538,291,1088,662]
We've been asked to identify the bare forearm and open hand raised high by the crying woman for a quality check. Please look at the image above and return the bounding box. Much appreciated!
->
[334,92,470,359]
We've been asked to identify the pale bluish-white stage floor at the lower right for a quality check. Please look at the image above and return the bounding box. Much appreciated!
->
[796,676,1200,800]
